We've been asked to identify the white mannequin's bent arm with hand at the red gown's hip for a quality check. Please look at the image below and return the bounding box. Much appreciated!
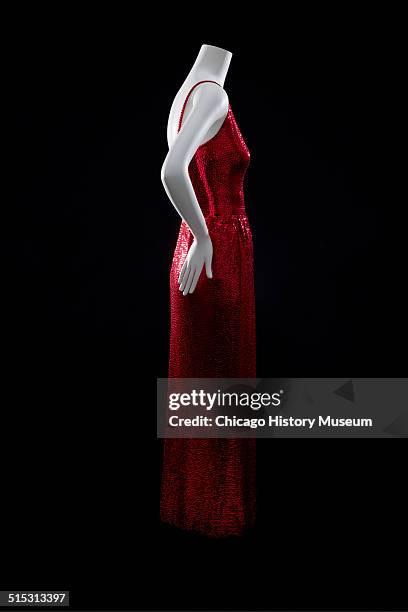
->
[162,83,228,295]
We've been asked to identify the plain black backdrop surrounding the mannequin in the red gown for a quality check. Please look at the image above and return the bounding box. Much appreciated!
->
[1,9,407,610]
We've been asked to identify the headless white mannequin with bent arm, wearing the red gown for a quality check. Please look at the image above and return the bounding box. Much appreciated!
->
[161,45,232,295]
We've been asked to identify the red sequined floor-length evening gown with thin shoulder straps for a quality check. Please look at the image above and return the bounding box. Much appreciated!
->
[160,81,256,537]
